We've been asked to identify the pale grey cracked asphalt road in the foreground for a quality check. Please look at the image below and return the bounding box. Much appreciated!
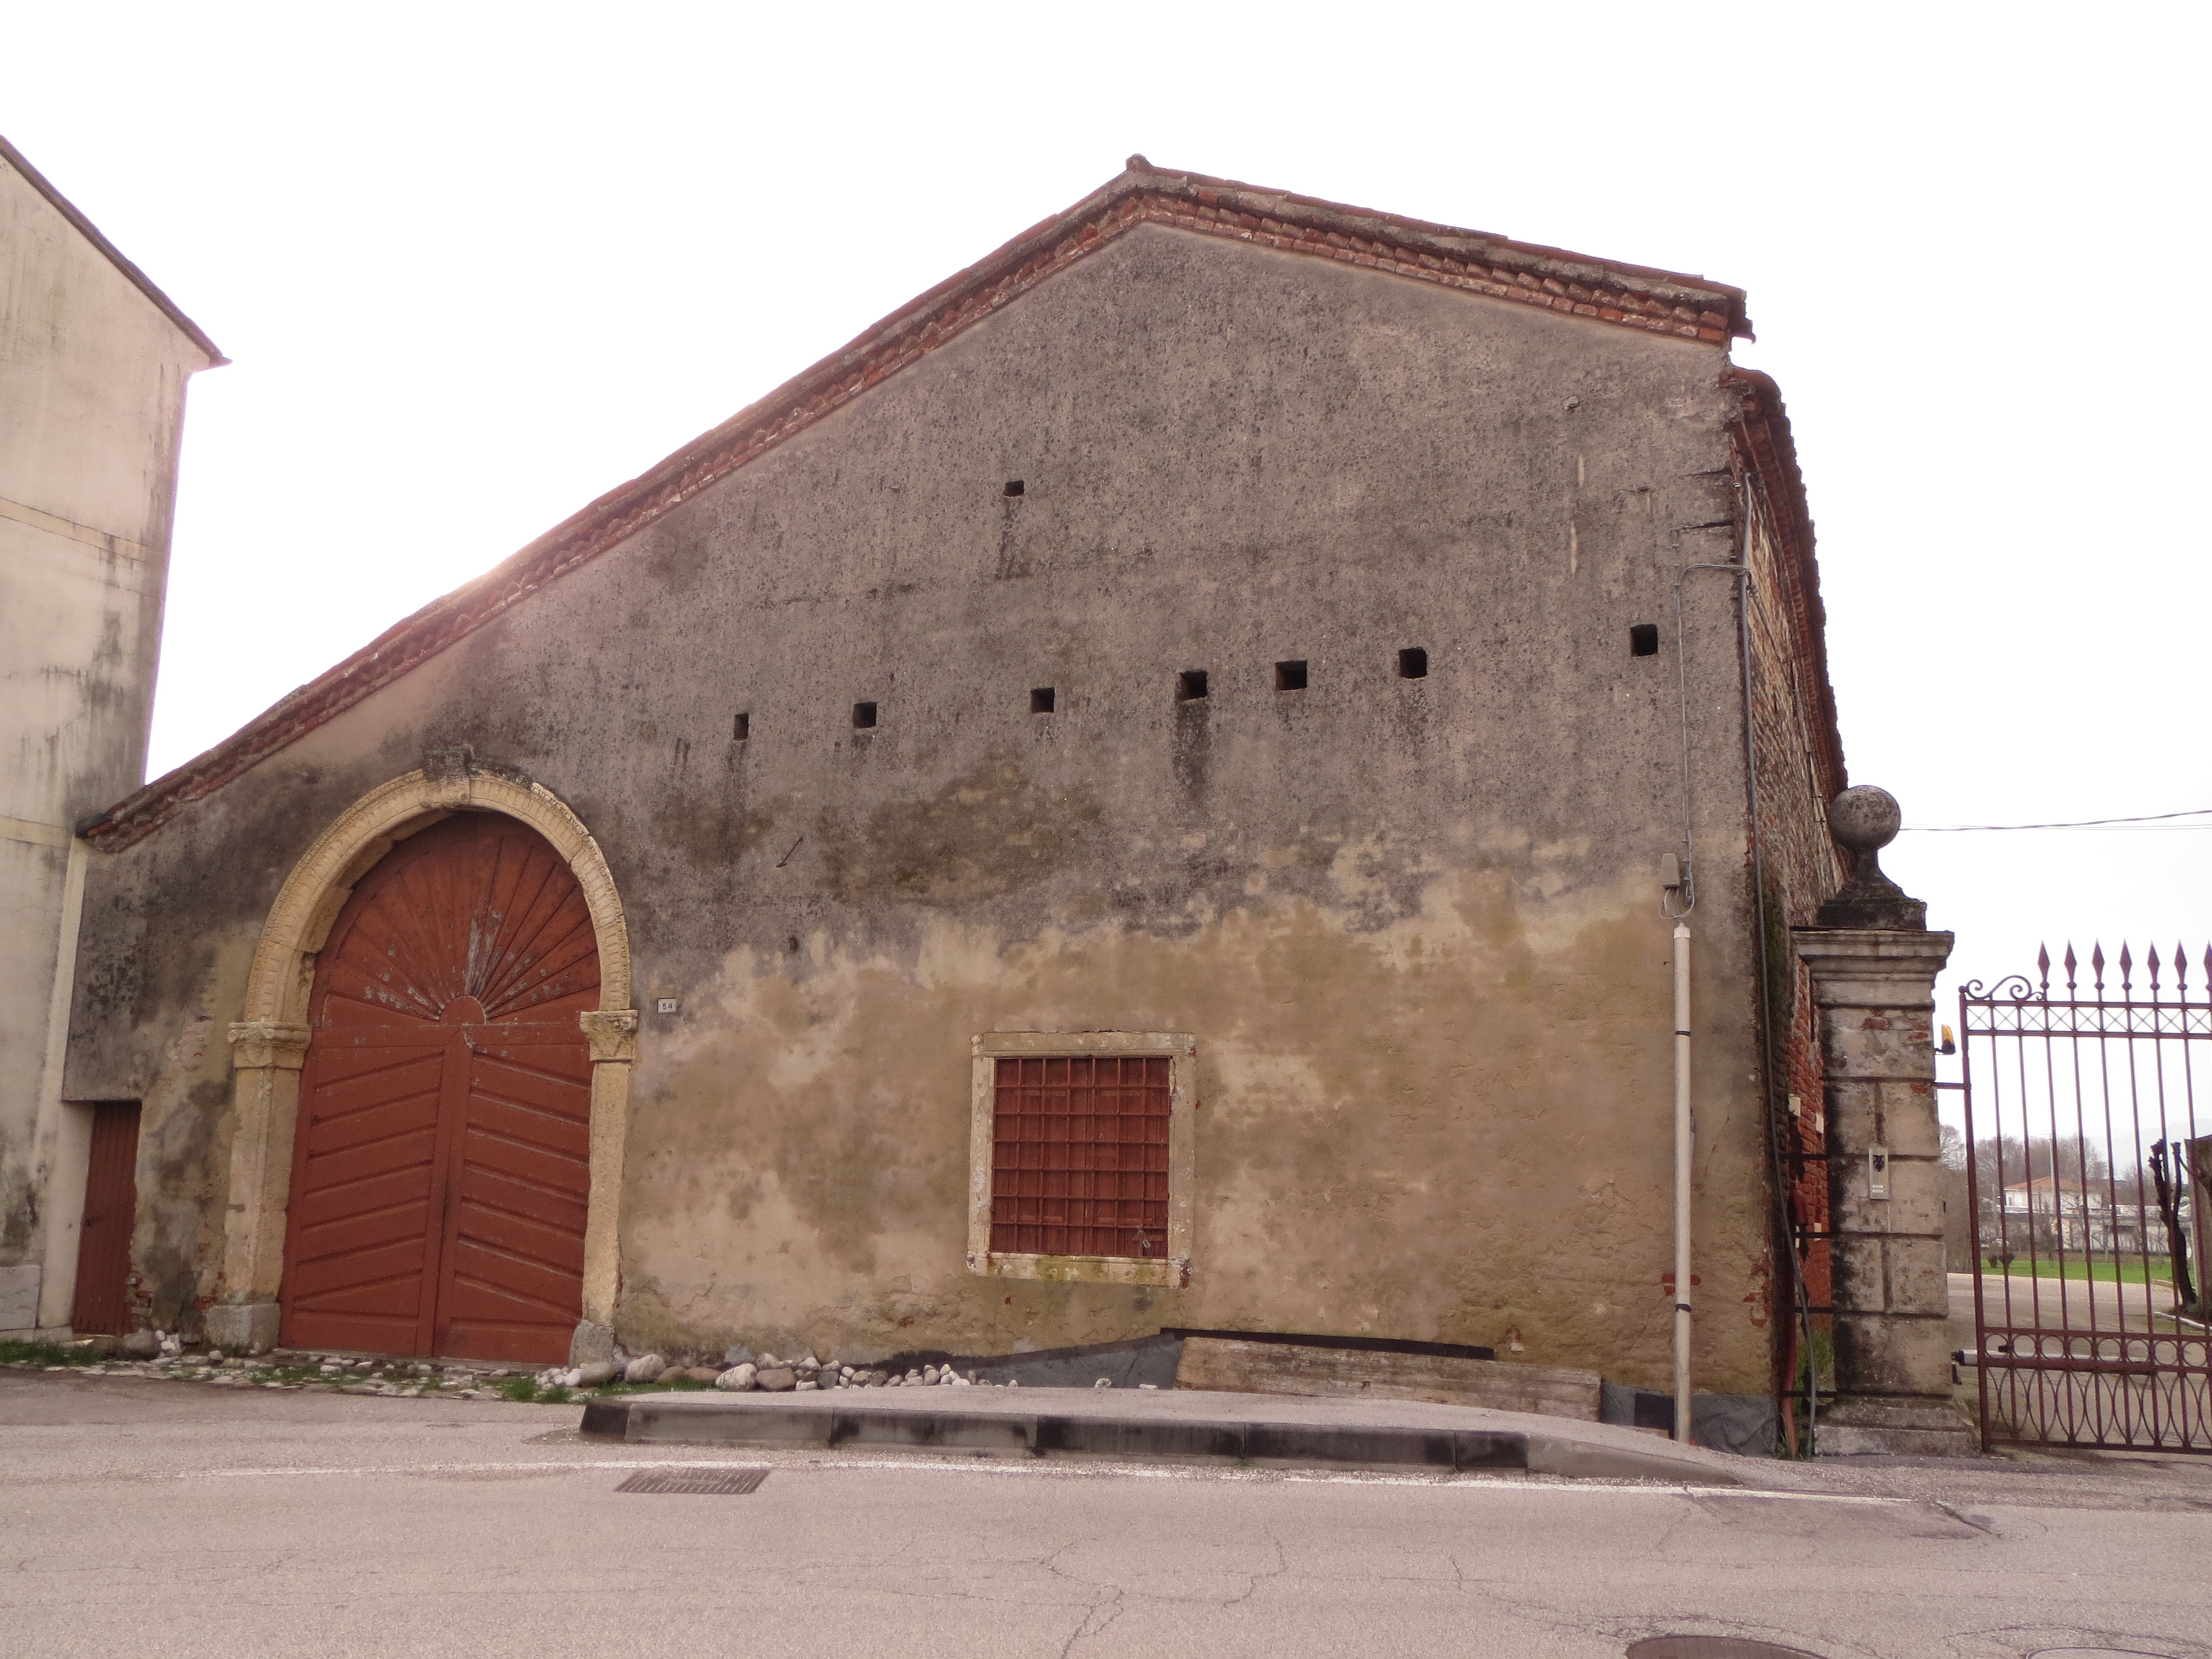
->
[0,1372,2212,1659]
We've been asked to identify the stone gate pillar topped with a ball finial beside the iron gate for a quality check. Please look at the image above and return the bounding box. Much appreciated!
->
[1792,788,1976,1455]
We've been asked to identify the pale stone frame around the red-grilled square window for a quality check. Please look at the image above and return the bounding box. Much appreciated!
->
[967,1031,1199,1287]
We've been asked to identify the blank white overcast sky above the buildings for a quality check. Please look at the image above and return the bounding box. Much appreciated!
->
[0,2,2212,1066]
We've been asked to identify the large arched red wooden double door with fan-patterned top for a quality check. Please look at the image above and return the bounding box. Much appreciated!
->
[281,812,600,1361]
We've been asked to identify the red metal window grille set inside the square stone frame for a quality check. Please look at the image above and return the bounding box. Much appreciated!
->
[991,1055,1168,1259]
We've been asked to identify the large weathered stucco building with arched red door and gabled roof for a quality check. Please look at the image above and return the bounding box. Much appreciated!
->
[43,159,1843,1393]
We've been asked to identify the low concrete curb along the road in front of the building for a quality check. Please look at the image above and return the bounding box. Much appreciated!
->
[581,1393,1743,1486]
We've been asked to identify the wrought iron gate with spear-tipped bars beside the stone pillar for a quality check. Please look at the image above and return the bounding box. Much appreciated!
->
[1951,945,2212,1453]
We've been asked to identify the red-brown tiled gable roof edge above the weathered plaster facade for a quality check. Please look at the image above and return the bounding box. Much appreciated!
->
[79,155,1760,851]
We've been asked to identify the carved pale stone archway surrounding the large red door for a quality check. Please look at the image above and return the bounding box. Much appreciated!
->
[208,752,637,1356]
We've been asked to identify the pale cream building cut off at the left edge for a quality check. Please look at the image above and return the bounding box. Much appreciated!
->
[0,139,223,1332]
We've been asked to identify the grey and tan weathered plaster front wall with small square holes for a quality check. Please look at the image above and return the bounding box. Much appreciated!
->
[71,228,1768,1389]
